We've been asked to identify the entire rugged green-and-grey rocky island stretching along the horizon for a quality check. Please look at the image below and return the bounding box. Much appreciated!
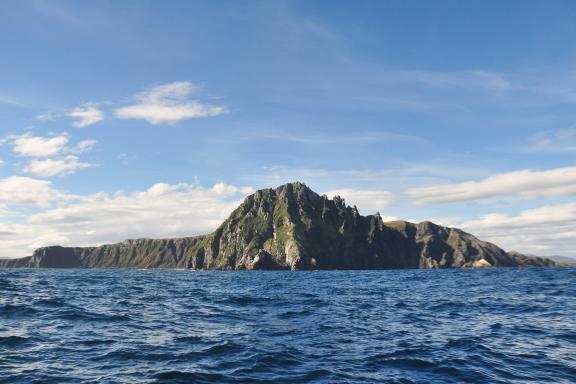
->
[0,182,559,270]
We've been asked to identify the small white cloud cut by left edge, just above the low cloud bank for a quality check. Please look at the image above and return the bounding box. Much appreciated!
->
[0,176,64,207]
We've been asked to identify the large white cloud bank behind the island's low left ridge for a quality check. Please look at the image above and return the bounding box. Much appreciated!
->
[0,182,253,257]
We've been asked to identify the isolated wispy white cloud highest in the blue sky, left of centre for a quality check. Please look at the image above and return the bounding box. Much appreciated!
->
[115,81,227,124]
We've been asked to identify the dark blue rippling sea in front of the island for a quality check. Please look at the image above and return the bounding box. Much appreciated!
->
[0,268,576,383]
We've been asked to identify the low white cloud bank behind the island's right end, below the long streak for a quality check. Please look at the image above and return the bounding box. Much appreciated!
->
[459,203,576,256]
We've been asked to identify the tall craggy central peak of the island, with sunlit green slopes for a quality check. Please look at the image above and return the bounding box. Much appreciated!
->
[200,183,417,269]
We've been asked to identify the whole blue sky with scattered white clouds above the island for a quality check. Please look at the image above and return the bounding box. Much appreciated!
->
[0,0,576,257]
